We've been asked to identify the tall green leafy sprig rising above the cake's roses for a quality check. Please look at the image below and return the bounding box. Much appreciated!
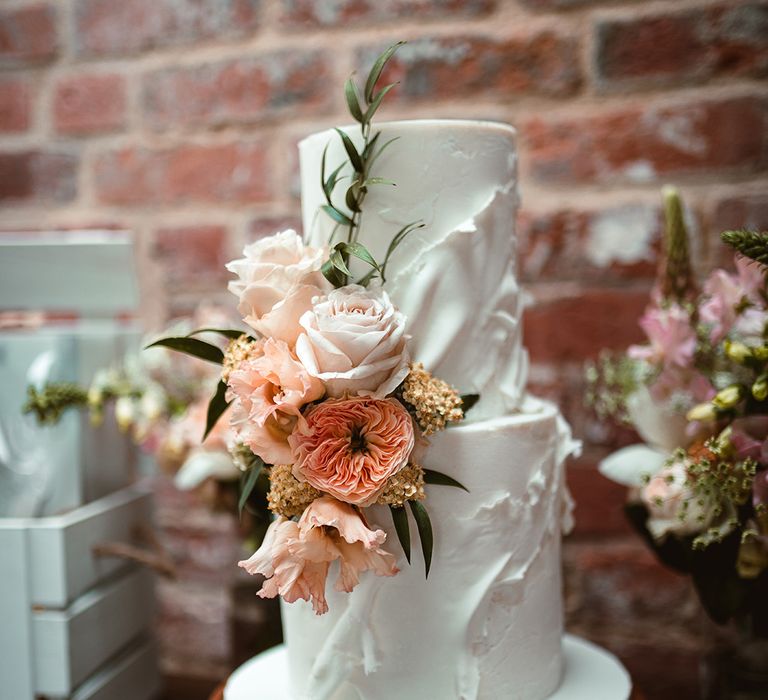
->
[320,41,423,288]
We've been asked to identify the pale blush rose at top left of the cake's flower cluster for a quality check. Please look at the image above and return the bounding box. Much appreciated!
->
[226,229,330,345]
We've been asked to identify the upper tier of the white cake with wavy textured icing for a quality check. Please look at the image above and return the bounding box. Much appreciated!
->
[299,120,527,420]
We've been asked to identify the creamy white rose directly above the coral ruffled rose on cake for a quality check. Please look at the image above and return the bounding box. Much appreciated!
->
[296,284,409,398]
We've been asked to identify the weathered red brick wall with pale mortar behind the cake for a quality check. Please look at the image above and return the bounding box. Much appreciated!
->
[0,0,768,698]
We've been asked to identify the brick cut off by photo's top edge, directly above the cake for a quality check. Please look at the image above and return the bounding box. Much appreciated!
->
[281,0,497,28]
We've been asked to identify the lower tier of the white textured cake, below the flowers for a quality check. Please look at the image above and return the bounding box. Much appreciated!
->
[282,399,574,700]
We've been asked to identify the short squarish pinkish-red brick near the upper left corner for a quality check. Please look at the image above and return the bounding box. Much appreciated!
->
[53,74,126,134]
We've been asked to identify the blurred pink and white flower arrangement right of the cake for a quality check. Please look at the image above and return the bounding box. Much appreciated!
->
[587,188,768,637]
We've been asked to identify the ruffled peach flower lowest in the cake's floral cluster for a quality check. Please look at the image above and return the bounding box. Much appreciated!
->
[238,496,398,615]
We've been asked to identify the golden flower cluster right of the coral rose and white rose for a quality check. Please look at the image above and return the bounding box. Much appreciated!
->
[400,362,464,435]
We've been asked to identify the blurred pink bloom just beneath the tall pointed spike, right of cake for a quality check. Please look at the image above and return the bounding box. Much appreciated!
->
[628,304,696,368]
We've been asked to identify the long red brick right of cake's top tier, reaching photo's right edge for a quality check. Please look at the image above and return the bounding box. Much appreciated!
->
[523,96,768,185]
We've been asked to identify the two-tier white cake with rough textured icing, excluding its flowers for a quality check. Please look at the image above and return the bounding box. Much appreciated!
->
[264,120,574,700]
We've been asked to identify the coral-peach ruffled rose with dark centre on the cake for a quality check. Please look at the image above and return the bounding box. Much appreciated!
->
[288,396,414,506]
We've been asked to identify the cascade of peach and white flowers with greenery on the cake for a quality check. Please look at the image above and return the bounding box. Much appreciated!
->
[149,44,477,614]
